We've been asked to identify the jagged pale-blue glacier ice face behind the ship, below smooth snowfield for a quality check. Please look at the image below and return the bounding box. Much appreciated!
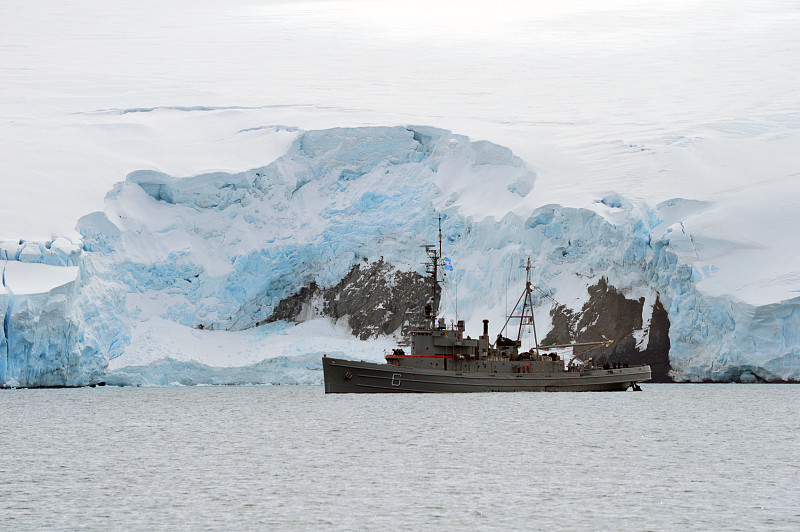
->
[0,126,800,387]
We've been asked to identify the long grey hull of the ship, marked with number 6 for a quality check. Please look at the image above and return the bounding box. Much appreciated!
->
[322,357,650,393]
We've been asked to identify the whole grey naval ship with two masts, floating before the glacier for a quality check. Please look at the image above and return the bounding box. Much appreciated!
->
[322,220,650,393]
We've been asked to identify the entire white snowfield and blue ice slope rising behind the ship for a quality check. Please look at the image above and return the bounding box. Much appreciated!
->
[0,0,800,384]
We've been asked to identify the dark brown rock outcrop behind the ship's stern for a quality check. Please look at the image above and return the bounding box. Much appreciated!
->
[542,279,672,382]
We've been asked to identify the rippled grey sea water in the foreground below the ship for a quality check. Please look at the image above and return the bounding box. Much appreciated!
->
[0,384,800,530]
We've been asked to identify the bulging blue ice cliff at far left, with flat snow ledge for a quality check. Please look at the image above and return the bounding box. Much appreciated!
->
[0,242,127,387]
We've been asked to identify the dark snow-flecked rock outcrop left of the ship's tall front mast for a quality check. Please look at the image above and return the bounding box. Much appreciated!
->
[257,258,438,340]
